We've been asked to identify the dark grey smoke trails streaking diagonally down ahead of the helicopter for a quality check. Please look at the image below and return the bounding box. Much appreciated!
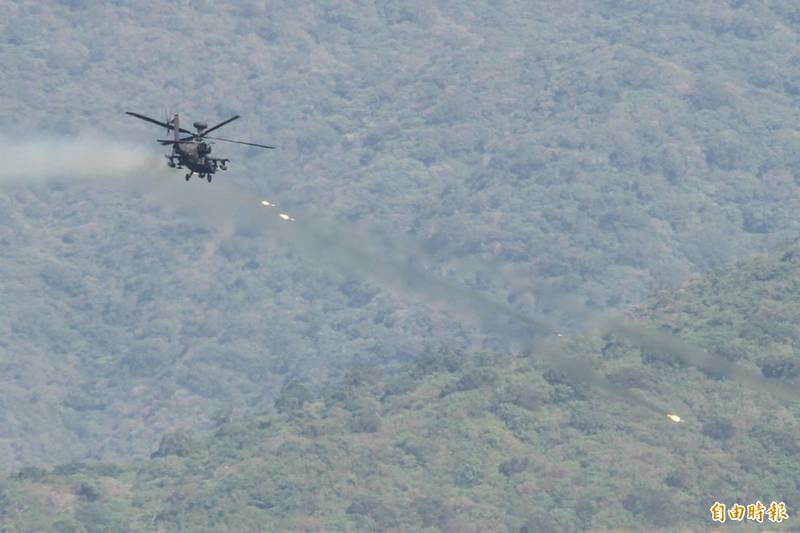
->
[139,177,798,422]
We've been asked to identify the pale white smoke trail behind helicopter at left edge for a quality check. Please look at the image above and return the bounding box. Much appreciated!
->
[0,133,159,183]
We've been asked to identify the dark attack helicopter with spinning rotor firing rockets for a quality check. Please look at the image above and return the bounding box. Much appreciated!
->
[125,111,275,183]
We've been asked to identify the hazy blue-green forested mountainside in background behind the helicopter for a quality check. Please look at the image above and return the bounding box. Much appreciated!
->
[0,0,800,470]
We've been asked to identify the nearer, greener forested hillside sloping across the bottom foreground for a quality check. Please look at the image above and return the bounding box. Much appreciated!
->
[6,244,800,533]
